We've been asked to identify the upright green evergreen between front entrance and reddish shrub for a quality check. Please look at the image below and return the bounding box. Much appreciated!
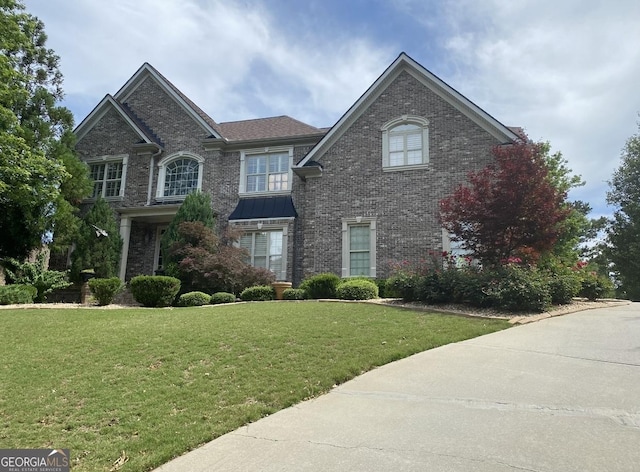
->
[160,192,215,278]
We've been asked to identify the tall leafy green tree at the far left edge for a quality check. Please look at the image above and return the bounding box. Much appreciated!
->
[0,0,90,259]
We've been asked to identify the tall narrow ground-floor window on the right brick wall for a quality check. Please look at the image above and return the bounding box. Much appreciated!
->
[342,218,376,277]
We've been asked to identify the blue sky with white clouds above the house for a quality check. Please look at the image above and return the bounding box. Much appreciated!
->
[25,0,640,217]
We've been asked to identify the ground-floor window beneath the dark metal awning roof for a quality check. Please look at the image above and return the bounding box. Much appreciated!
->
[239,229,286,280]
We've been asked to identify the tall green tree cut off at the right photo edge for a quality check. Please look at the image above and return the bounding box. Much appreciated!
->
[606,123,640,300]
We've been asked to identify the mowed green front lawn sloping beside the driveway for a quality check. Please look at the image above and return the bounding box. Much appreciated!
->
[0,301,508,471]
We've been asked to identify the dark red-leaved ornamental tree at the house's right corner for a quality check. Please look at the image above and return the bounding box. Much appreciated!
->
[440,141,570,266]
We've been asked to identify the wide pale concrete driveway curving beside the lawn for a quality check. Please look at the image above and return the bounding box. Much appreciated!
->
[157,303,640,472]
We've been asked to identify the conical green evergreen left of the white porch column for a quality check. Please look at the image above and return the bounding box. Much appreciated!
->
[71,198,122,280]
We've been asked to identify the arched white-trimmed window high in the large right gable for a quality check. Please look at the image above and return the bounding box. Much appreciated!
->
[382,115,429,170]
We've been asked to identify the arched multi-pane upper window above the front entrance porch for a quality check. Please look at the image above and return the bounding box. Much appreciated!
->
[156,152,204,199]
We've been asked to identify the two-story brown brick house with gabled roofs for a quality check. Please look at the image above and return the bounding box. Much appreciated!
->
[76,53,518,284]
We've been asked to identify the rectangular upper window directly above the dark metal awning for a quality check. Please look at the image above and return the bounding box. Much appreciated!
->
[240,148,293,194]
